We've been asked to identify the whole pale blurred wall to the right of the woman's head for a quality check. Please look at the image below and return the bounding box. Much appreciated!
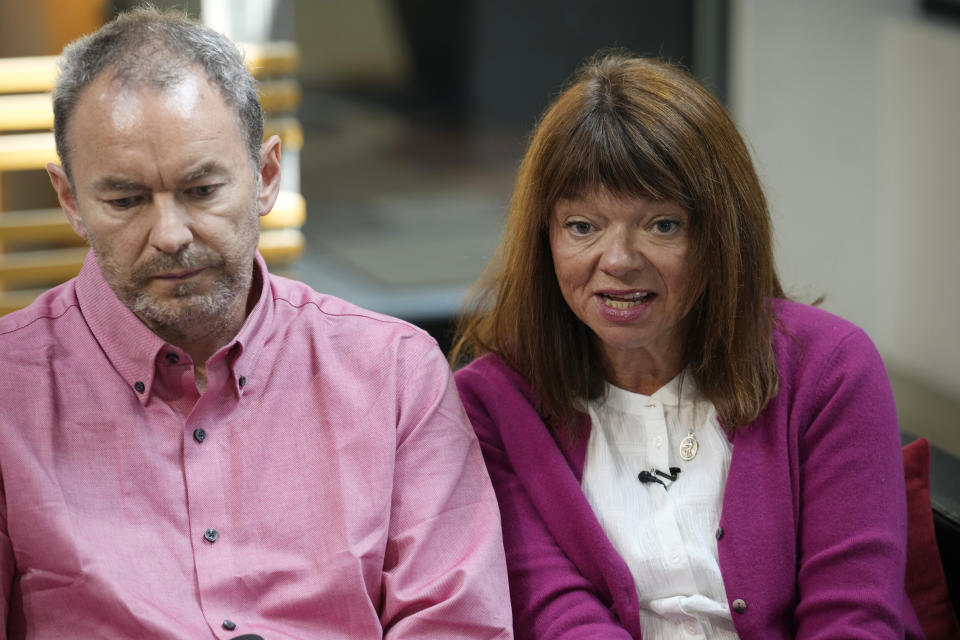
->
[730,0,960,430]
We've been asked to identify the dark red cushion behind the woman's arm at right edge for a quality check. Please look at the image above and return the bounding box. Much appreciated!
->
[903,438,960,640]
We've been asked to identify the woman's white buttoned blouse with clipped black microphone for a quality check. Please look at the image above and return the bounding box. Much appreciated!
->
[582,375,737,640]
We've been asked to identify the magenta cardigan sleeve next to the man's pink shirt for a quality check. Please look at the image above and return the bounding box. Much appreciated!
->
[456,369,632,640]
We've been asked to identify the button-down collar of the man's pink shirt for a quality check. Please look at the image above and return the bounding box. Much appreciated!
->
[76,251,273,404]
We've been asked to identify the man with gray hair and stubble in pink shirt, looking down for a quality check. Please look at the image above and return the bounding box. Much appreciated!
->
[0,10,511,638]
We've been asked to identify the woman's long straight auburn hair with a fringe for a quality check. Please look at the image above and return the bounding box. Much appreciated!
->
[450,52,784,437]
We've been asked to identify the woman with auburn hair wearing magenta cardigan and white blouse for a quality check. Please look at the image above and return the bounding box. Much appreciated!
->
[451,55,920,640]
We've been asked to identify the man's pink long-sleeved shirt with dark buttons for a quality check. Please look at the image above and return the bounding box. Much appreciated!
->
[0,255,511,640]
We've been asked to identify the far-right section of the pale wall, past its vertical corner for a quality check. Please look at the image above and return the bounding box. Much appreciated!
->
[881,20,960,396]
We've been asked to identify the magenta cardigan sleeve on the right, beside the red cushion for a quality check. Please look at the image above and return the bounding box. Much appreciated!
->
[794,330,906,640]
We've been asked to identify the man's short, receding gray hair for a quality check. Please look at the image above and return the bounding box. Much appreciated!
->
[53,7,263,176]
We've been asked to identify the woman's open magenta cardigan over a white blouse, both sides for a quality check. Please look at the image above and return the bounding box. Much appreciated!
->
[456,301,923,640]
